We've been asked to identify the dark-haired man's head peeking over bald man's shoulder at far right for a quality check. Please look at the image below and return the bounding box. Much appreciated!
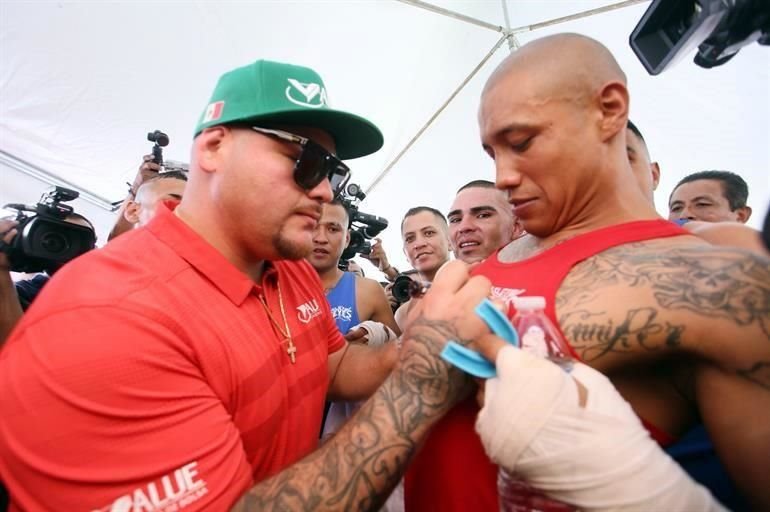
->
[668,171,751,224]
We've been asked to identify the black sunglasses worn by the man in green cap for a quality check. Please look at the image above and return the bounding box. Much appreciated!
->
[251,126,350,197]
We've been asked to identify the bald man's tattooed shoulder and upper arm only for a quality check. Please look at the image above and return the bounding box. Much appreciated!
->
[556,240,770,372]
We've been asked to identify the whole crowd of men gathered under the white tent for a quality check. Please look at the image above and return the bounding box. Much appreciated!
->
[0,34,770,512]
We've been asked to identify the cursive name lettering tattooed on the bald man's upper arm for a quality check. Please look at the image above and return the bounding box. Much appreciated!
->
[559,308,684,362]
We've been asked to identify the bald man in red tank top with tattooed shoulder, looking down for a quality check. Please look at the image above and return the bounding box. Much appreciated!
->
[405,34,770,510]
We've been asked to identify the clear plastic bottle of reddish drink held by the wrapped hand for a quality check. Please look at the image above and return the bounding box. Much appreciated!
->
[497,297,575,512]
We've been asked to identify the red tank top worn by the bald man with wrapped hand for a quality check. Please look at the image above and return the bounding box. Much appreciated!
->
[404,220,689,512]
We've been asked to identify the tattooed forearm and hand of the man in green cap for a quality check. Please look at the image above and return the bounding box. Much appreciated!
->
[232,262,489,512]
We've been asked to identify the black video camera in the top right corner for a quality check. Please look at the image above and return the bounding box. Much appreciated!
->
[629,0,770,75]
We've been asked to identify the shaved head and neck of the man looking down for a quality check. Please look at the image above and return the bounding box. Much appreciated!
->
[479,34,654,237]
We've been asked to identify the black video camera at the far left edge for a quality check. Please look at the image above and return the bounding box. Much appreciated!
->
[2,187,96,274]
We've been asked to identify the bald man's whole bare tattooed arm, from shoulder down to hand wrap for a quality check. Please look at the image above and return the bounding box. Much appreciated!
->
[557,242,770,509]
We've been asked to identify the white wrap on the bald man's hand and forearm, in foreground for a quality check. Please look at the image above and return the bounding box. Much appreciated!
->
[476,347,725,512]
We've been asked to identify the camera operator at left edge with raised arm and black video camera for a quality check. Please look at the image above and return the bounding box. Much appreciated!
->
[0,187,96,345]
